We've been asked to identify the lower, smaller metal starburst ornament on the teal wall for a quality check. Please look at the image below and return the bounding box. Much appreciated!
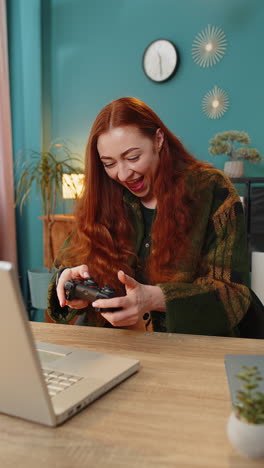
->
[202,86,229,119]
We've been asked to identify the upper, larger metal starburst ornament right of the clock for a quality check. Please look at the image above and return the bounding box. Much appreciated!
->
[192,24,227,67]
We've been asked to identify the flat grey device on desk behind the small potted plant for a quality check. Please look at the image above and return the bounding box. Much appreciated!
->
[225,354,264,404]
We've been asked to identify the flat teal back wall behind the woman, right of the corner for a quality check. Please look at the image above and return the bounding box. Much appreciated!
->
[50,0,264,167]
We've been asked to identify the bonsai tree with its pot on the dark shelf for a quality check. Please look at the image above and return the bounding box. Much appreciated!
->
[208,130,262,177]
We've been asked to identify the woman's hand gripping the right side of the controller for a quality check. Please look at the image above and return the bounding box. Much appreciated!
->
[92,271,166,327]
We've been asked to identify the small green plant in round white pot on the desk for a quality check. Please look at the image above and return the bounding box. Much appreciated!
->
[227,366,264,458]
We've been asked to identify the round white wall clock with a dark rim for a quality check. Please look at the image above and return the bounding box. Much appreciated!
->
[143,39,178,82]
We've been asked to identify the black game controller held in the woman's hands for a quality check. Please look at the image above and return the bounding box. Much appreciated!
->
[64,278,121,312]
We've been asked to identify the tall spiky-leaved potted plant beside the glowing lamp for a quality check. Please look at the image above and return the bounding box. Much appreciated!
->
[16,140,83,309]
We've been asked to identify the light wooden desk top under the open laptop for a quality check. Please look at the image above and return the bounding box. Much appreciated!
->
[0,323,264,468]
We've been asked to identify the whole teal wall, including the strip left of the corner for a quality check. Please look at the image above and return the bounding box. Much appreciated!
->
[7,0,264,318]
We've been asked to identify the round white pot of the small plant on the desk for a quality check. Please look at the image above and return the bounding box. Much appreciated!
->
[227,412,264,458]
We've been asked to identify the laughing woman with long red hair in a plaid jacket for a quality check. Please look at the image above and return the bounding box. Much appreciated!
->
[49,98,250,336]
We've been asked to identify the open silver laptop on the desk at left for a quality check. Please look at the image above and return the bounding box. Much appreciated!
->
[0,261,139,426]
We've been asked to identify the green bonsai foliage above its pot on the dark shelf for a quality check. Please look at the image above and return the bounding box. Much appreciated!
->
[208,130,262,162]
